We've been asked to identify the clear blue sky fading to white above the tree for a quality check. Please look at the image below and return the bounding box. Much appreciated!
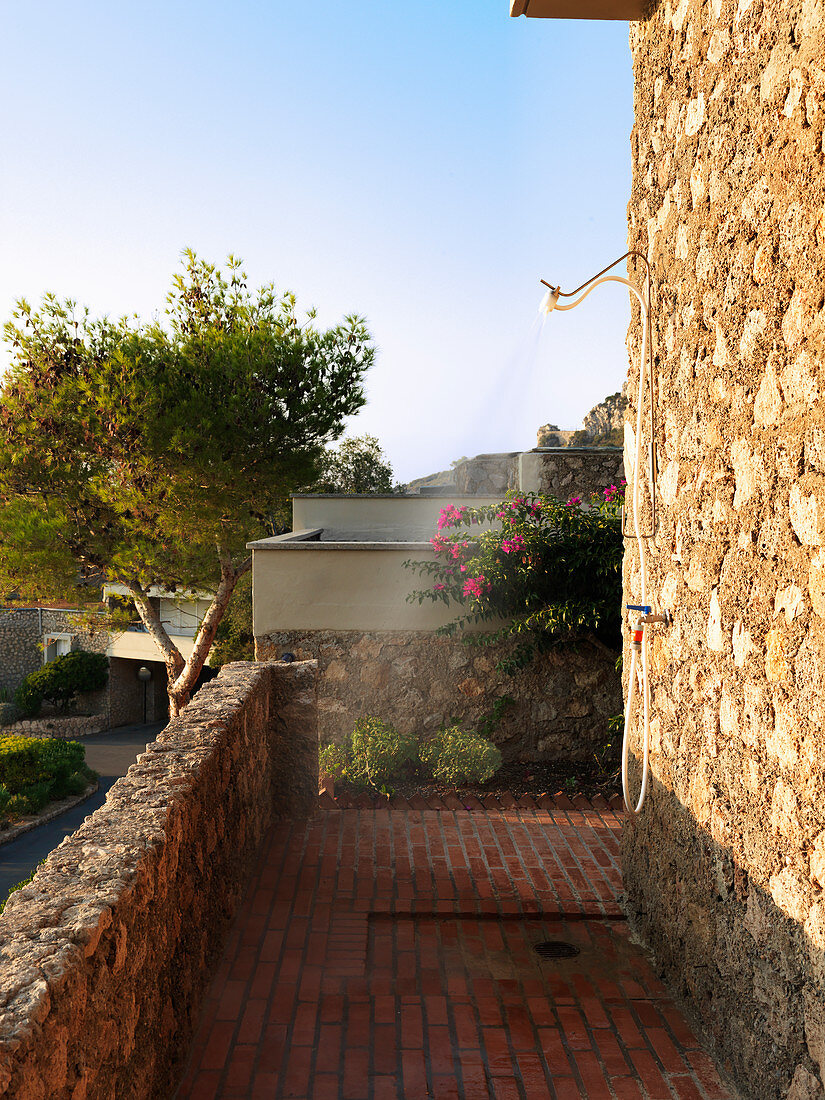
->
[0,0,633,480]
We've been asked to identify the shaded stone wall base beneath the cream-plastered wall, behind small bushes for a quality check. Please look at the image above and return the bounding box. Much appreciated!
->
[256,630,622,761]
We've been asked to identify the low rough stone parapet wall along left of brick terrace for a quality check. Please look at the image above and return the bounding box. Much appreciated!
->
[0,663,318,1100]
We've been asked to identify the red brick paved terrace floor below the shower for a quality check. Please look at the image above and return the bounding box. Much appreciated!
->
[178,810,730,1100]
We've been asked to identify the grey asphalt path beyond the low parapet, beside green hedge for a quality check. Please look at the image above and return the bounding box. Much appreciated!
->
[0,722,166,901]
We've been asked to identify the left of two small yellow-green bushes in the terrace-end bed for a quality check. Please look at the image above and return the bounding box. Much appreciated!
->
[320,717,418,794]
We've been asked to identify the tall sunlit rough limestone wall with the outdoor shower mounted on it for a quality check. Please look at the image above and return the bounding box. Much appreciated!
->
[624,0,825,1100]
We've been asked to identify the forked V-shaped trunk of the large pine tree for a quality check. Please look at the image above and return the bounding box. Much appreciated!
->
[127,547,252,718]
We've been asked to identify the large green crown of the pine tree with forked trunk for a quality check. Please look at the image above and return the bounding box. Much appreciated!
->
[0,252,374,708]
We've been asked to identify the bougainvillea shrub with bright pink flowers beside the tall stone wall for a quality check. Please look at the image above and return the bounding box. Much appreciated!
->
[405,481,625,672]
